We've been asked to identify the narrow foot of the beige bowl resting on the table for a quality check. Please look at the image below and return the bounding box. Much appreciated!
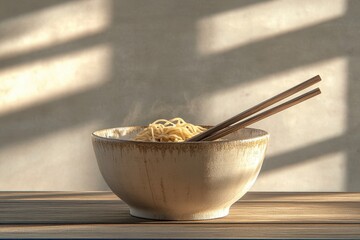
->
[130,207,230,220]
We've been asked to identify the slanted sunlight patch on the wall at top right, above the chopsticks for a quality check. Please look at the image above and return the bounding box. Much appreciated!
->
[197,0,347,56]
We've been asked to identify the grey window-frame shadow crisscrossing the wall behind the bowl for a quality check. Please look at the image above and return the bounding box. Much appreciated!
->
[0,0,360,191]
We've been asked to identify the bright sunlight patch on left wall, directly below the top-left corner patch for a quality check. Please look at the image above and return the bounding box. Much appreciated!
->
[0,45,112,115]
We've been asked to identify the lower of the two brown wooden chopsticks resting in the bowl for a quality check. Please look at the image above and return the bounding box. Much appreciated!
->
[202,88,321,141]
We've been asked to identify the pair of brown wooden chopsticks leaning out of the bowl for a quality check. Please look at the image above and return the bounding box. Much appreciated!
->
[187,75,321,142]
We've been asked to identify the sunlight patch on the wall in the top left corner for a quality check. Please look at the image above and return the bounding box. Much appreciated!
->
[0,0,112,57]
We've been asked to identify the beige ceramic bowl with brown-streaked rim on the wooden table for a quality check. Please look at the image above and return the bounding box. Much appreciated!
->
[92,127,269,220]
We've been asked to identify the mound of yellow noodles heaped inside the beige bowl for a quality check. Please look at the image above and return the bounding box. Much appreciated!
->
[134,118,205,142]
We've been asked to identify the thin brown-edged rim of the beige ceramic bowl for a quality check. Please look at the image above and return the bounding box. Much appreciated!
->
[91,125,270,145]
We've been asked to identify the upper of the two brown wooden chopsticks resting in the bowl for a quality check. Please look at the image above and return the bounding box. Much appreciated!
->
[187,75,321,142]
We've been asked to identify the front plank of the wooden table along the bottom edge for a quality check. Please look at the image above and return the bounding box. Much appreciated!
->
[0,223,360,239]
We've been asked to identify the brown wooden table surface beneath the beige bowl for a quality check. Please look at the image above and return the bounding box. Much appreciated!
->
[0,192,360,239]
